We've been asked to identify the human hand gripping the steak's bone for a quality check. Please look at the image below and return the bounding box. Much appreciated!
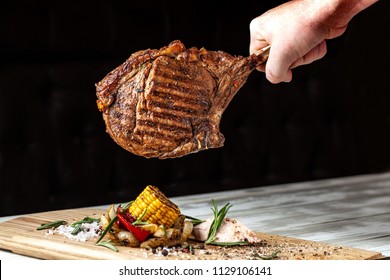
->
[250,0,376,83]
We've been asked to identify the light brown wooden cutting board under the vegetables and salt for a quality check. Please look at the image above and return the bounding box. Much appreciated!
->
[0,208,383,260]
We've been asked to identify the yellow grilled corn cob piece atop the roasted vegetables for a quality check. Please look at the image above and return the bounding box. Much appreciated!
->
[129,185,180,228]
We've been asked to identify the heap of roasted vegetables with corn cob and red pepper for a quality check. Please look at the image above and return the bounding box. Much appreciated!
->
[97,186,193,248]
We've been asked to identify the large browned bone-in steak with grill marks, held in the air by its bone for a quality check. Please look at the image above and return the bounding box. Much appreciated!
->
[96,40,267,159]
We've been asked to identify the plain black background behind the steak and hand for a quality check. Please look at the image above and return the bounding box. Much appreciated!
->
[0,0,390,216]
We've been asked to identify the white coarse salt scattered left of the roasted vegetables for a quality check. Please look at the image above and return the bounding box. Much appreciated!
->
[46,222,100,242]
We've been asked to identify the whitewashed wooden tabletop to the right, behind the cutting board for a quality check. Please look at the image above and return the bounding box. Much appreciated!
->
[174,173,390,256]
